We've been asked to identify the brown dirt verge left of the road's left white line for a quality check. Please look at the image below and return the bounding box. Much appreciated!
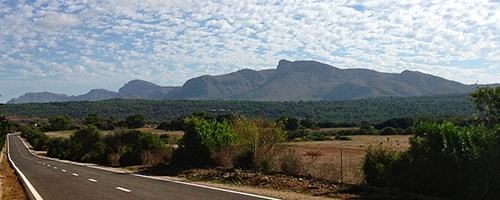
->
[0,144,27,200]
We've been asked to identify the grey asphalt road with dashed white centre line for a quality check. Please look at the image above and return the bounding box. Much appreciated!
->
[8,135,274,200]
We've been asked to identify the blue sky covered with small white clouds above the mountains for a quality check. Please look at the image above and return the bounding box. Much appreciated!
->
[0,0,500,102]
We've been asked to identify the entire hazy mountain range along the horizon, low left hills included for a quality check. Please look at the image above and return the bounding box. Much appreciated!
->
[7,60,488,103]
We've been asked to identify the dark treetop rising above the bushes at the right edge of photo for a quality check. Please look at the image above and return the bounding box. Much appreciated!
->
[471,87,500,124]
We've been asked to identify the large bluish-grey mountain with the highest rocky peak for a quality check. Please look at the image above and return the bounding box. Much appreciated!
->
[170,60,472,101]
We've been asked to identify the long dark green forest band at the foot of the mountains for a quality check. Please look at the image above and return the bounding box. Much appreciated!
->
[0,95,474,124]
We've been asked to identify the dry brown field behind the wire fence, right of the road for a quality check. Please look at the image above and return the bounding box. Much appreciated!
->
[288,135,410,183]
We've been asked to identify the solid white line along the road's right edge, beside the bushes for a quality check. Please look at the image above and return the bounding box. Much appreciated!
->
[17,136,280,200]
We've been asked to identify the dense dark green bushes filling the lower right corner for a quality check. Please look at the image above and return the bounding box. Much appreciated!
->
[363,87,500,199]
